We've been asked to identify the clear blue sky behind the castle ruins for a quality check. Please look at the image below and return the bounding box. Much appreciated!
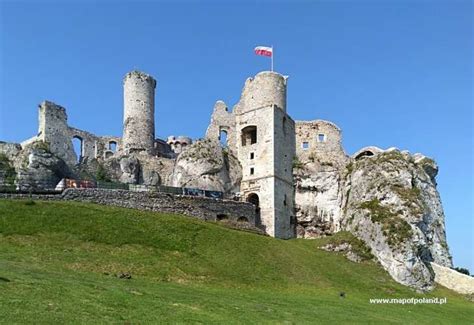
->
[0,0,474,272]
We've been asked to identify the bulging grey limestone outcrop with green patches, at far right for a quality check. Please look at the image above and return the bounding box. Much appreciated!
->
[342,149,452,291]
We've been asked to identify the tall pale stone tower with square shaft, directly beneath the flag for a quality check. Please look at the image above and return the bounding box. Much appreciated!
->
[233,71,295,238]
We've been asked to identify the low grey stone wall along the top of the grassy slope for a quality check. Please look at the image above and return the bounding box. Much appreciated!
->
[0,188,255,226]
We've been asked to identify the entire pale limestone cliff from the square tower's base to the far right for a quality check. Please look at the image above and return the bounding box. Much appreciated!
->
[295,149,452,291]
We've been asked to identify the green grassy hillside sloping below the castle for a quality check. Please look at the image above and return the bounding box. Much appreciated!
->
[0,200,474,324]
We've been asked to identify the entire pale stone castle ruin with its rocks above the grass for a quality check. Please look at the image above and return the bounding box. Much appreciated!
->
[0,67,452,290]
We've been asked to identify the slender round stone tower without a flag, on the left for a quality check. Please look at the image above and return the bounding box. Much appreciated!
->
[123,71,156,153]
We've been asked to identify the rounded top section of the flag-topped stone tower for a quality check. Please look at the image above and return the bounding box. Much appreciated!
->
[241,71,287,112]
